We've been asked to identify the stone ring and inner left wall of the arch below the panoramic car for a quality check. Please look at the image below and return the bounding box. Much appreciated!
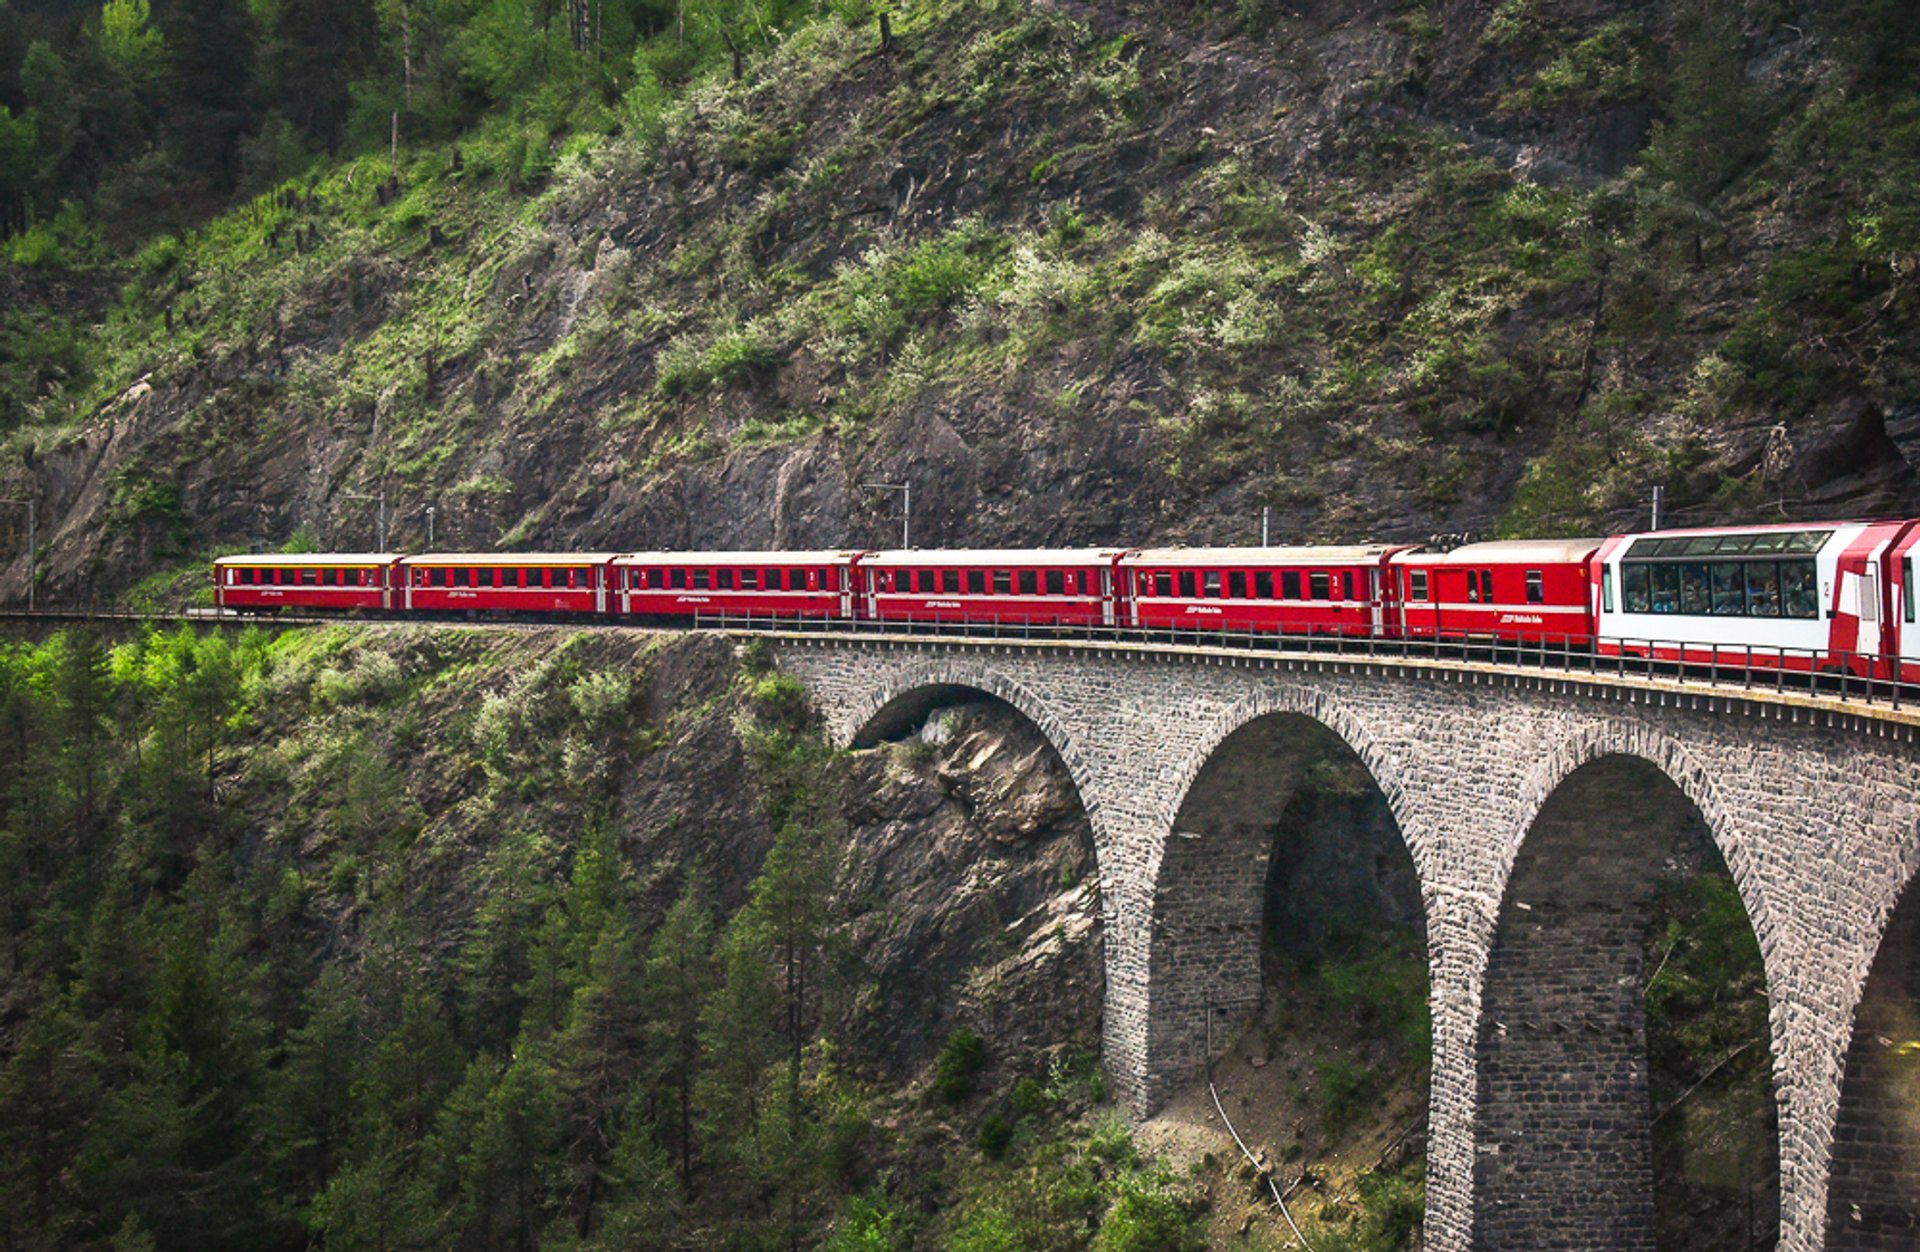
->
[1471,720,1780,1252]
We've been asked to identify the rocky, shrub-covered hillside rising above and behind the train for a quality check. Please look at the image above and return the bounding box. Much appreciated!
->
[0,0,1920,597]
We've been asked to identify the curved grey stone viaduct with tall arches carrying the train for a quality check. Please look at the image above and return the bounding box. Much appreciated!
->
[772,636,1920,1252]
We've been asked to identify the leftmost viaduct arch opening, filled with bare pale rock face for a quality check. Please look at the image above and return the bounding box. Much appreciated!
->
[845,684,1106,1091]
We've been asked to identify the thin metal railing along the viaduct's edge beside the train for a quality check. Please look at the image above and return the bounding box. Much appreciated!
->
[693,613,1920,709]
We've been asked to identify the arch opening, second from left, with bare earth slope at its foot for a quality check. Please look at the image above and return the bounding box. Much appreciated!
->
[1150,712,1432,1246]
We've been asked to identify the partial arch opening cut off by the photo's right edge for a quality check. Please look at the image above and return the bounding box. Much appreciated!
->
[1826,860,1920,1252]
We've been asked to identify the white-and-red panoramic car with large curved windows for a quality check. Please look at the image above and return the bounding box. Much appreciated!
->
[1592,520,1914,678]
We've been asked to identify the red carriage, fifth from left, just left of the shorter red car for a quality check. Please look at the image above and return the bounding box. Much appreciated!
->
[1119,543,1409,636]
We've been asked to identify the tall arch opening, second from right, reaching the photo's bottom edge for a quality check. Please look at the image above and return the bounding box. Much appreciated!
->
[1473,755,1780,1252]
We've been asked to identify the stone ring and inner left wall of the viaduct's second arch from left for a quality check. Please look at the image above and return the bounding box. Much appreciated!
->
[1135,684,1428,1114]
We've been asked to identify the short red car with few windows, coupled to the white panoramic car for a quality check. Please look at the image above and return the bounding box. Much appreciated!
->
[1394,540,1603,647]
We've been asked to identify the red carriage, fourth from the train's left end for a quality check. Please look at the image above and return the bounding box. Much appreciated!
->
[858,547,1123,626]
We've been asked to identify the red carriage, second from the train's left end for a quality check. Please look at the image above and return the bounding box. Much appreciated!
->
[397,553,616,613]
